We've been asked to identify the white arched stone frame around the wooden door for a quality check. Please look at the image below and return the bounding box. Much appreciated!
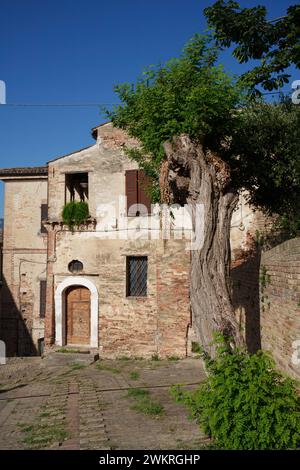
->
[54,276,99,348]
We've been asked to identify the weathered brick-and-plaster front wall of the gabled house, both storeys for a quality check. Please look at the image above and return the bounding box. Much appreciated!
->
[46,124,190,357]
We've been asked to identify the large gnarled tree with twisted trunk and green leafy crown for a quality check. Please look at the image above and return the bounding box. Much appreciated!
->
[109,35,300,349]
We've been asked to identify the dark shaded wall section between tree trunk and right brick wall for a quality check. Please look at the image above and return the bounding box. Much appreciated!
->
[231,247,261,353]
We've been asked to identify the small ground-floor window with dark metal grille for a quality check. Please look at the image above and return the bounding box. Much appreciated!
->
[126,256,148,297]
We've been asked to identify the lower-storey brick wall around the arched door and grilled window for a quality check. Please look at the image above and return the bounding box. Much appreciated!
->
[49,230,190,358]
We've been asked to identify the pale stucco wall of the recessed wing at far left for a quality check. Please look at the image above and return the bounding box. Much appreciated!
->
[1,179,47,355]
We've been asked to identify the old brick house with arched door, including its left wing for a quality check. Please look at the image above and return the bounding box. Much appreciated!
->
[0,123,262,357]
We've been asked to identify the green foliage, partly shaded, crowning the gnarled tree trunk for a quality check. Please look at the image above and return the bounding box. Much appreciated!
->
[108,35,300,220]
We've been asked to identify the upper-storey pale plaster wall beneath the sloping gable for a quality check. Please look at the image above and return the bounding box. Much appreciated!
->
[49,124,138,227]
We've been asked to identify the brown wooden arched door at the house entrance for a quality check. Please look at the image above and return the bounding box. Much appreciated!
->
[66,286,91,345]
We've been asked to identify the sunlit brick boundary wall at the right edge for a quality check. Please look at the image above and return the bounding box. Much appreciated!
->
[260,238,300,378]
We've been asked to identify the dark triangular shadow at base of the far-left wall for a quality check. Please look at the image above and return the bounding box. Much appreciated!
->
[0,277,38,357]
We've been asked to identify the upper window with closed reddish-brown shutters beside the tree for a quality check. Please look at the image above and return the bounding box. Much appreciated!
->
[125,170,151,217]
